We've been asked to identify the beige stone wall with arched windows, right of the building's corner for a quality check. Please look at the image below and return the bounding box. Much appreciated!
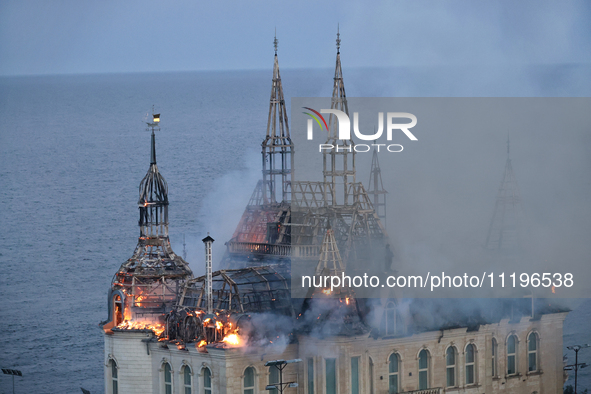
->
[299,313,566,394]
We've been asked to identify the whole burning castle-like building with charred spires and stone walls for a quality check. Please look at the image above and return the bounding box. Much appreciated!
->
[101,35,566,394]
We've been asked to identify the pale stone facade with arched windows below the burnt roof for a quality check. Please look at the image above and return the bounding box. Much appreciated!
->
[105,313,566,394]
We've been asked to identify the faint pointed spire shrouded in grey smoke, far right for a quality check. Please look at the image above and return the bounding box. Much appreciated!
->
[485,137,523,252]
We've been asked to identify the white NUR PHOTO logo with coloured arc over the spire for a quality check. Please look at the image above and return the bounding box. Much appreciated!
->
[303,107,418,153]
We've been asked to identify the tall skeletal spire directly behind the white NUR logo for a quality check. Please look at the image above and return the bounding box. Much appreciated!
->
[323,28,356,205]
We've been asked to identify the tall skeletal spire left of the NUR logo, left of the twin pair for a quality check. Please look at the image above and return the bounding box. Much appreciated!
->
[261,36,293,204]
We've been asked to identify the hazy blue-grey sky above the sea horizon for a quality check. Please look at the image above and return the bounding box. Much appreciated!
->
[0,0,591,75]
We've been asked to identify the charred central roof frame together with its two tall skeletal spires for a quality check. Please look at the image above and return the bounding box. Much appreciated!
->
[221,33,387,272]
